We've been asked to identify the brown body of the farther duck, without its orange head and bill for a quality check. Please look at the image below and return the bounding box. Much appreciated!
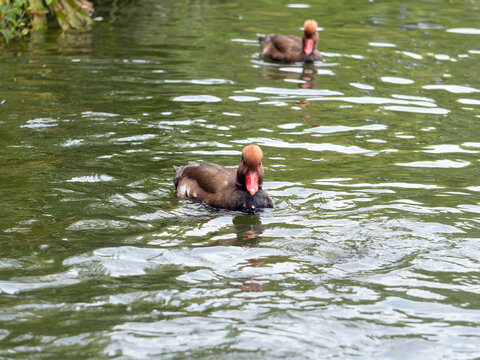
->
[257,34,323,63]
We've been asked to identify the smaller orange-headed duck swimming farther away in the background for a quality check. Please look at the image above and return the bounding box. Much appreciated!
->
[257,20,323,63]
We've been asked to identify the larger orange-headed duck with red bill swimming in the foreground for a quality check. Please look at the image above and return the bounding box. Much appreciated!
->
[173,144,273,213]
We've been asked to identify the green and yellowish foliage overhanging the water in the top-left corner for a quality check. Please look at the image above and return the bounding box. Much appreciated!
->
[0,0,93,43]
